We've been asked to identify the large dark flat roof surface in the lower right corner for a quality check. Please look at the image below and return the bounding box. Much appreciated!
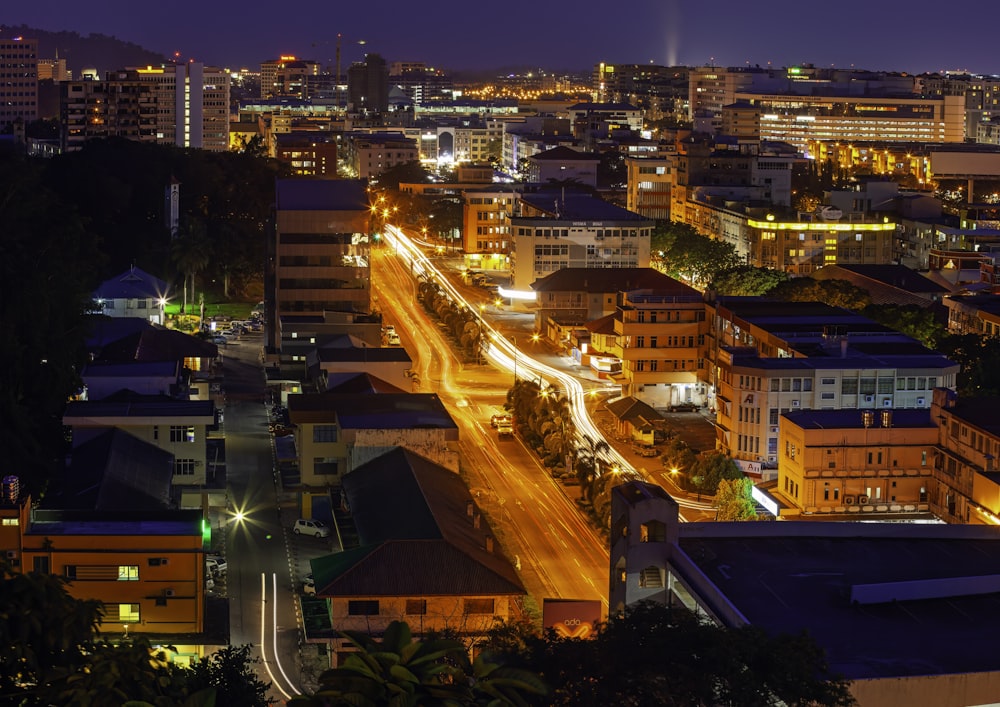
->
[680,521,1000,679]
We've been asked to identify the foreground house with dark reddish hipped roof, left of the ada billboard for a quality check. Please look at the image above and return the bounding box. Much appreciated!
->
[311,448,525,653]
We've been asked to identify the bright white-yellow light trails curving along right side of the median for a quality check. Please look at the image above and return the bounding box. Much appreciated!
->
[384,224,712,511]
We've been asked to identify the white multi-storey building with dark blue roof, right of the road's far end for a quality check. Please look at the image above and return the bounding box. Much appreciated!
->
[510,191,653,291]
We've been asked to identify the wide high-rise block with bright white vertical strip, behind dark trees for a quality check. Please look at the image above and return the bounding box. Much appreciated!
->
[60,63,229,152]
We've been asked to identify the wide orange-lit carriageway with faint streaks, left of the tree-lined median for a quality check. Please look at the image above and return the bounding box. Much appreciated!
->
[372,249,608,608]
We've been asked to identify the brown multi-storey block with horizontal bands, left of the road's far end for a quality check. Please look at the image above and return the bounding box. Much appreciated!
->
[265,179,371,352]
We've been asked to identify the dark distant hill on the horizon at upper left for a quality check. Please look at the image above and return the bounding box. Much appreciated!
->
[0,25,166,79]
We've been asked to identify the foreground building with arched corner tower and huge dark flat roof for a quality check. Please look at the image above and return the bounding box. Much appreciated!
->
[608,481,1000,707]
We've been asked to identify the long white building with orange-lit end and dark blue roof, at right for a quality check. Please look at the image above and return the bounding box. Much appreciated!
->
[707,297,959,469]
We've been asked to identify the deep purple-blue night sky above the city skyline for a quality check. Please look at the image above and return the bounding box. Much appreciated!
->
[7,0,1000,74]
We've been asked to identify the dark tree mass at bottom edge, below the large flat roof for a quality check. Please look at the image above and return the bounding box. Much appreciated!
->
[482,603,854,707]
